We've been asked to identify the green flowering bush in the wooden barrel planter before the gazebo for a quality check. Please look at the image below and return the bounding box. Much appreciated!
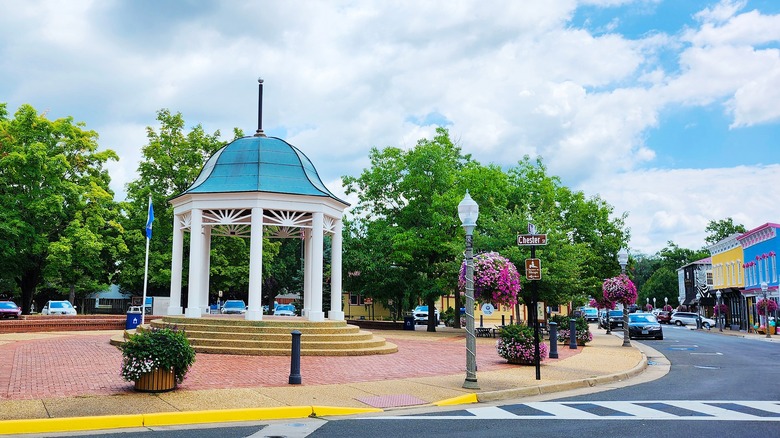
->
[119,327,195,383]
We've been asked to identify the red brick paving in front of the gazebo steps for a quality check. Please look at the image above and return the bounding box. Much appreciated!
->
[0,331,587,400]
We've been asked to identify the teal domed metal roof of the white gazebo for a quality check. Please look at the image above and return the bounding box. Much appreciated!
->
[182,136,349,205]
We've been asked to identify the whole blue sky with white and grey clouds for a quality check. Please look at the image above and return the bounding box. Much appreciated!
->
[0,0,780,254]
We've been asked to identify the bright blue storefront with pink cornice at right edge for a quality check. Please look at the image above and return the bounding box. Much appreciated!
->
[737,223,780,328]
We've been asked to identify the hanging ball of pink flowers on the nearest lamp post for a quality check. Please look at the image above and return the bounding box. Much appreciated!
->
[458,252,520,306]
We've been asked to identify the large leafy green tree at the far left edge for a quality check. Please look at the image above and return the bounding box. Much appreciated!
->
[0,104,125,313]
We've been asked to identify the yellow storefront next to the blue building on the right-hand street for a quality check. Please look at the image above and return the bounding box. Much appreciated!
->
[707,233,752,330]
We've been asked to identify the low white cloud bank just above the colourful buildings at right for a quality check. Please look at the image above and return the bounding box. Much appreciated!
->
[578,164,780,254]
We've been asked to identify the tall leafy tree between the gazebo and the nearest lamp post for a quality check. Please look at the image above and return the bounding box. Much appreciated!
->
[343,128,472,331]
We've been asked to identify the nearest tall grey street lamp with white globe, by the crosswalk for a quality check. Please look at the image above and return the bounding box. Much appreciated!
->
[458,190,479,389]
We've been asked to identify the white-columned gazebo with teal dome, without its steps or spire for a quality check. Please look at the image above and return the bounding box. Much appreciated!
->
[168,133,349,322]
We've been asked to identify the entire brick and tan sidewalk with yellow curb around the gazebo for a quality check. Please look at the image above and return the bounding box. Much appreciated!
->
[0,327,647,434]
